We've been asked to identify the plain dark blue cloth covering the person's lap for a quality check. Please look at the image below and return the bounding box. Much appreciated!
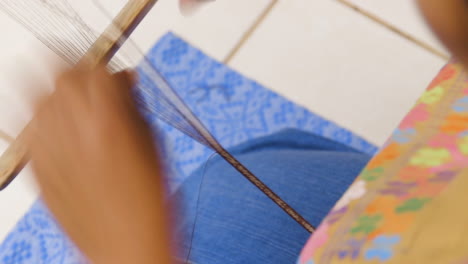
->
[173,130,370,264]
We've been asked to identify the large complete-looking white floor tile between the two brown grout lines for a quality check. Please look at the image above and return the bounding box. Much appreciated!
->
[230,0,444,144]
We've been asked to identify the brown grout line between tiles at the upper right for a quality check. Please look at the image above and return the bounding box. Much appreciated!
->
[336,0,450,60]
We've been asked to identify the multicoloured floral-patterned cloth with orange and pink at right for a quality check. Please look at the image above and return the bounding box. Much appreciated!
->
[298,62,468,264]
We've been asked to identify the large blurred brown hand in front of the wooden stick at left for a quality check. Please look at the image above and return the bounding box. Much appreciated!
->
[30,68,171,264]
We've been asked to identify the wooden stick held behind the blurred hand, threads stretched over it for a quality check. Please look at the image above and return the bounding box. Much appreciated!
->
[0,0,157,190]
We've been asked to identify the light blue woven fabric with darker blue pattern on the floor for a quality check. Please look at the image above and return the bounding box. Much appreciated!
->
[0,33,376,264]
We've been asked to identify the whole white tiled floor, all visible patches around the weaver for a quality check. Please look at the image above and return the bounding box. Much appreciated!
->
[0,0,446,240]
